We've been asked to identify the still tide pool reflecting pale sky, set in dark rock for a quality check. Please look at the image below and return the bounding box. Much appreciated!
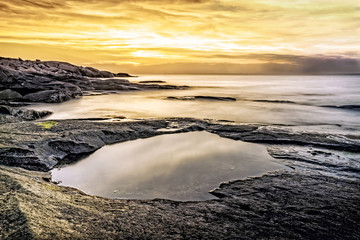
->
[52,132,284,201]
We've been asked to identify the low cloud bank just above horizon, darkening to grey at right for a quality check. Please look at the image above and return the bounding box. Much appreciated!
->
[92,55,360,75]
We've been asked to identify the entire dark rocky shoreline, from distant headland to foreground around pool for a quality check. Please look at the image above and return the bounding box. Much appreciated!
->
[0,58,360,239]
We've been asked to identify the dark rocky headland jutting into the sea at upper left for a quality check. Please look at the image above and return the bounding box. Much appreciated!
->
[0,58,184,103]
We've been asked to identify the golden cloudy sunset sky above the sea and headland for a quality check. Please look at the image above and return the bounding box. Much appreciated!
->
[0,0,360,74]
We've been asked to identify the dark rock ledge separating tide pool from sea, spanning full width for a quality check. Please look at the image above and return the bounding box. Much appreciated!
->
[0,117,360,170]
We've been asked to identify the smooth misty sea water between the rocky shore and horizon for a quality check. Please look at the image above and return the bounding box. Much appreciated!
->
[31,75,360,131]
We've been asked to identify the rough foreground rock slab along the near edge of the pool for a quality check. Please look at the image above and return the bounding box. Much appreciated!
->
[0,167,360,239]
